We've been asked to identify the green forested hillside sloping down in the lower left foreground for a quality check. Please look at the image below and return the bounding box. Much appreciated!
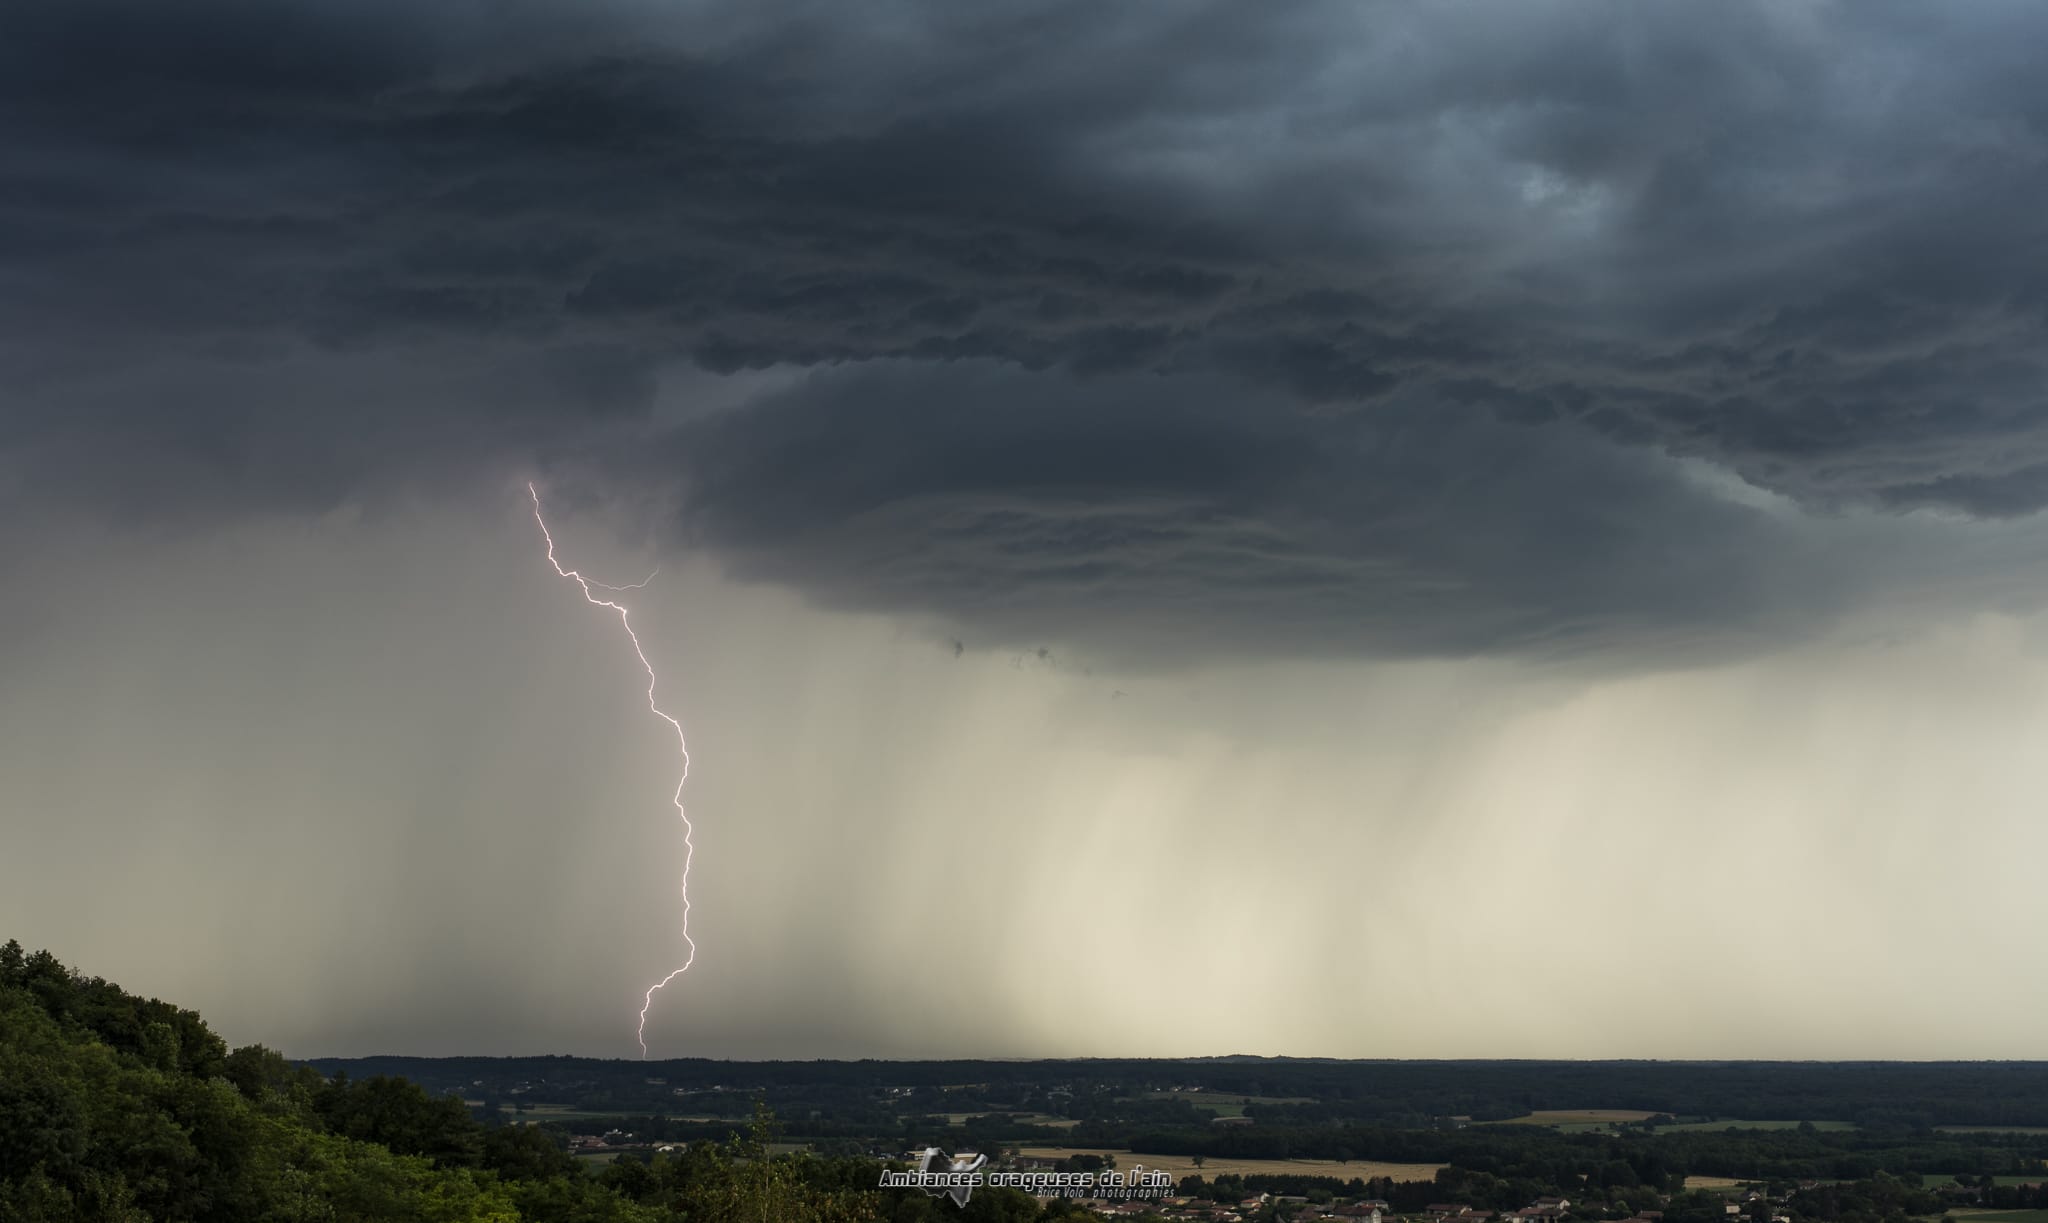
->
[0,942,1036,1223]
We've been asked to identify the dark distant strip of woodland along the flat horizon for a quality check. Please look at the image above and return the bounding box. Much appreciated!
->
[311,1057,2048,1131]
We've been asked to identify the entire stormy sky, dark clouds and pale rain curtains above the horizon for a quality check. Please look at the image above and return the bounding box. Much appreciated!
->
[0,0,2048,1059]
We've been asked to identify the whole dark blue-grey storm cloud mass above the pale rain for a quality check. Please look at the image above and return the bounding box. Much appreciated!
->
[12,2,2048,649]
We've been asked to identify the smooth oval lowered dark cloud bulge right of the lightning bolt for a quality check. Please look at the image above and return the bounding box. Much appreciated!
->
[667,363,1864,662]
